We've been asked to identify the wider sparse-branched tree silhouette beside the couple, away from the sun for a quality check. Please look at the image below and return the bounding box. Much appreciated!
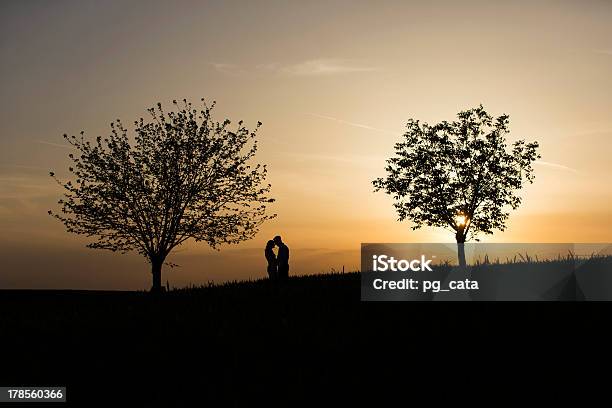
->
[49,99,275,291]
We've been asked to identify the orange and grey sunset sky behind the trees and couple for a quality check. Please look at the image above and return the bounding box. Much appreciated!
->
[0,0,612,289]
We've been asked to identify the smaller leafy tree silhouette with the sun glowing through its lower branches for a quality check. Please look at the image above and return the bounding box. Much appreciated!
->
[373,105,540,266]
